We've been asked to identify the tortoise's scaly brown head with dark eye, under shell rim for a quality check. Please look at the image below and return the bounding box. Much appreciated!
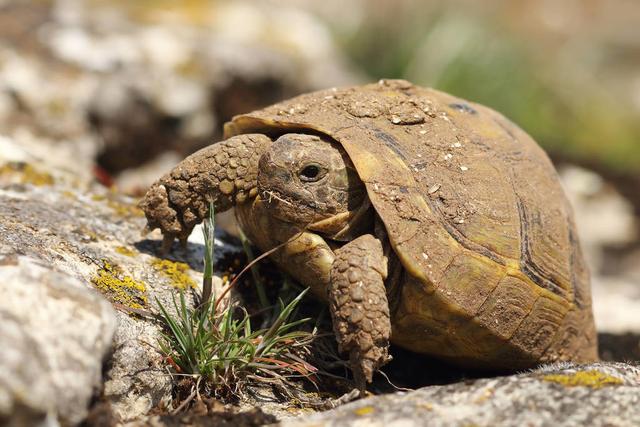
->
[258,134,370,240]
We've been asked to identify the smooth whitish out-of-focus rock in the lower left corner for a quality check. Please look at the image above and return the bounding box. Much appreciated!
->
[0,256,116,425]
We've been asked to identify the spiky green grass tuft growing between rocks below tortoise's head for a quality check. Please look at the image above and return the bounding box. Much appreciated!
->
[156,202,317,402]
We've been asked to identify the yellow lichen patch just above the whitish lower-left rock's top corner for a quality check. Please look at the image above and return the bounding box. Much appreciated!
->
[91,261,147,308]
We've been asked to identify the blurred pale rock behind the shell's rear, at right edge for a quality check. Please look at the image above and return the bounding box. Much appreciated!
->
[560,165,640,336]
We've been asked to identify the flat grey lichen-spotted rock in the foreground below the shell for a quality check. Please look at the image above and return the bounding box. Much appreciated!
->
[280,363,640,427]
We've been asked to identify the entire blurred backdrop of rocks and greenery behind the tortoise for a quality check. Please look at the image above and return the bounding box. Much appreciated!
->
[0,0,640,359]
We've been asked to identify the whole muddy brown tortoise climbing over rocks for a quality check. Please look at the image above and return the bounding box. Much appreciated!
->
[141,80,597,390]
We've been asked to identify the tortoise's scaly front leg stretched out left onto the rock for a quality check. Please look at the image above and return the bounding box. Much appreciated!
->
[140,134,271,249]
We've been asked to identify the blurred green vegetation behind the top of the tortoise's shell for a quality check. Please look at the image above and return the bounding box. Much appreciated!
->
[334,4,640,175]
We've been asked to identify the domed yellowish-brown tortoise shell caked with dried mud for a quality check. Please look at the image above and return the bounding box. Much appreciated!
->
[225,80,597,367]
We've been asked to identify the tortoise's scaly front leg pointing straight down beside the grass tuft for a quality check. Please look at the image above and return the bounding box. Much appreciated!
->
[329,234,391,392]
